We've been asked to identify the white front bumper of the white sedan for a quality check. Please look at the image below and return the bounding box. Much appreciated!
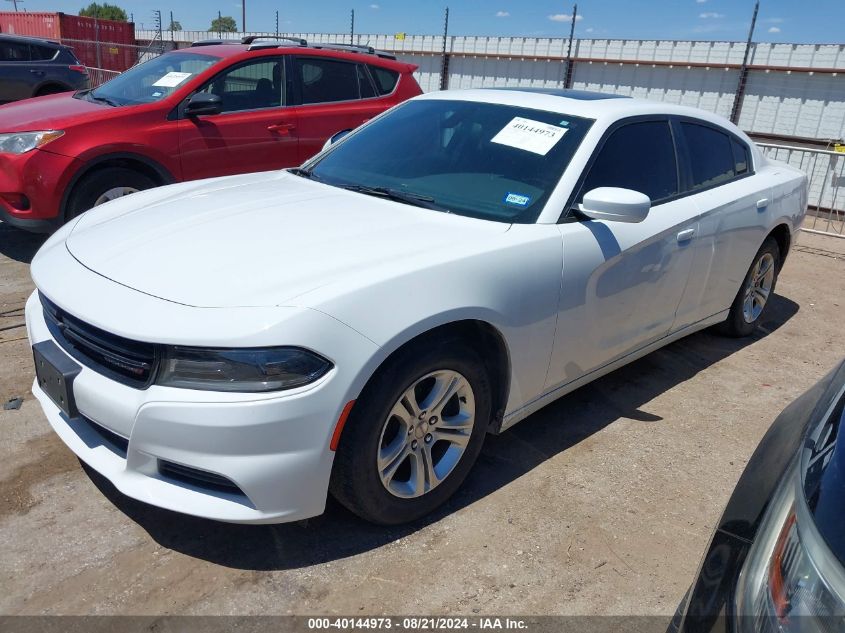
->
[26,293,376,523]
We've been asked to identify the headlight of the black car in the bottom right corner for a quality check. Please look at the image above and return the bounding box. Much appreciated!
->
[736,460,845,633]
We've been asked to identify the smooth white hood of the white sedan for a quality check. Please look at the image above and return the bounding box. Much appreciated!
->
[66,172,509,307]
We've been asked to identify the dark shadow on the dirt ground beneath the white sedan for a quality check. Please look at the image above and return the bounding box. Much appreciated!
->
[83,295,798,570]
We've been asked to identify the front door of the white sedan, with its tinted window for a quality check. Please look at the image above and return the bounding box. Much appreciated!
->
[547,120,699,388]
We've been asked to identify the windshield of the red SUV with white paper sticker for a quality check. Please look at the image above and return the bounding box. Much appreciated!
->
[81,53,220,106]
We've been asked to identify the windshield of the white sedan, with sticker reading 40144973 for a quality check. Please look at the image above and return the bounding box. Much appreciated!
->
[304,99,593,223]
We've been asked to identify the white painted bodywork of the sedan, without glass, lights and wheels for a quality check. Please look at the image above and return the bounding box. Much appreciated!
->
[27,90,806,523]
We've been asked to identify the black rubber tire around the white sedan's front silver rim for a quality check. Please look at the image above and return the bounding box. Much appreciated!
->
[330,339,492,525]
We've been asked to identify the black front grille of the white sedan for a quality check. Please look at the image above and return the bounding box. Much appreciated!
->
[39,293,159,389]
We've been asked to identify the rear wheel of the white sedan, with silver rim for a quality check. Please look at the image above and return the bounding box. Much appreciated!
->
[720,237,781,337]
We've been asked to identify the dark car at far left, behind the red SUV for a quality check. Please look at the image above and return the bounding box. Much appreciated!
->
[0,35,88,103]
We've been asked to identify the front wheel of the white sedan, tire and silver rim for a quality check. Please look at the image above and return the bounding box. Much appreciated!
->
[331,341,491,525]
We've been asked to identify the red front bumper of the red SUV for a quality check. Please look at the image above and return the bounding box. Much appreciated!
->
[0,149,76,232]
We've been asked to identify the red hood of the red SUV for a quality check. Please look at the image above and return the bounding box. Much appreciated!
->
[0,92,107,133]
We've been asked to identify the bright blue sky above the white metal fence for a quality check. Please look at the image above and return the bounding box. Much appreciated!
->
[14,0,845,44]
